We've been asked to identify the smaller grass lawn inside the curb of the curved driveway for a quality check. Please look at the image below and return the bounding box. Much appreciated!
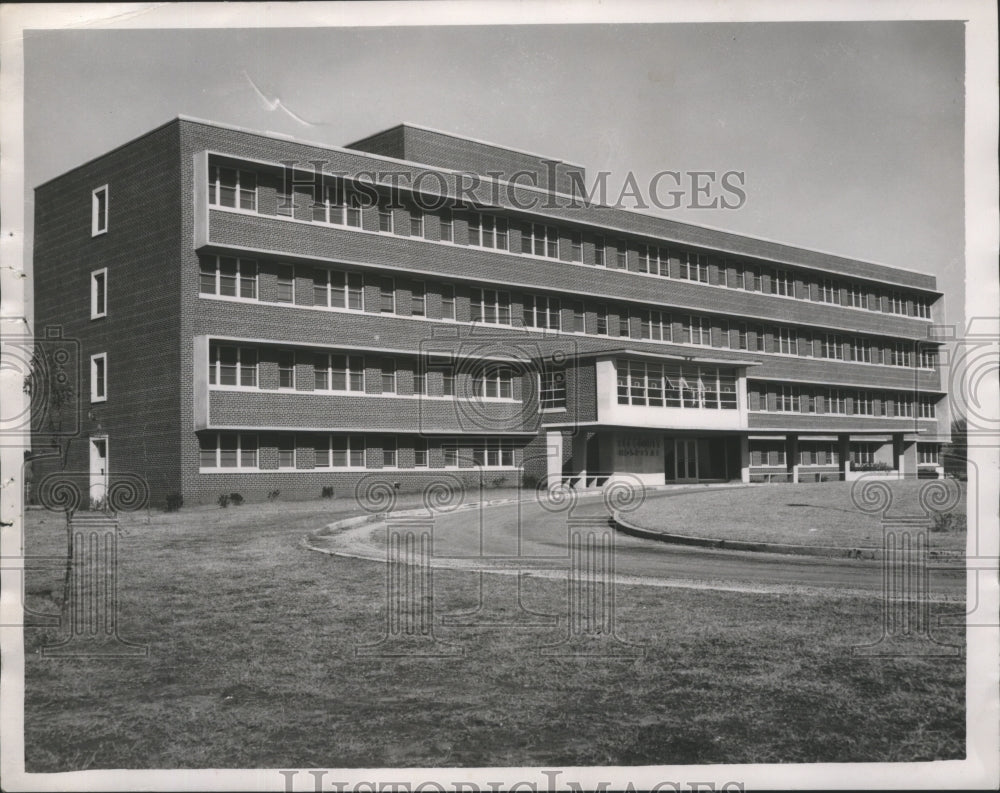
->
[627,480,966,550]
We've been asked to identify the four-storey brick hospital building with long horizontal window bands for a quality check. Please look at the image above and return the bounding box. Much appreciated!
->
[34,118,948,503]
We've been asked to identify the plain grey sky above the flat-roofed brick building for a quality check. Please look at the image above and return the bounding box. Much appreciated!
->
[24,21,964,325]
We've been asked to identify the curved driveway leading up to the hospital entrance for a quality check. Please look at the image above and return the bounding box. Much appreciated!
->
[312,498,965,600]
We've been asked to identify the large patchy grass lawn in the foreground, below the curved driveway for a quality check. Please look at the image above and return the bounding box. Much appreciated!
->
[19,496,965,768]
